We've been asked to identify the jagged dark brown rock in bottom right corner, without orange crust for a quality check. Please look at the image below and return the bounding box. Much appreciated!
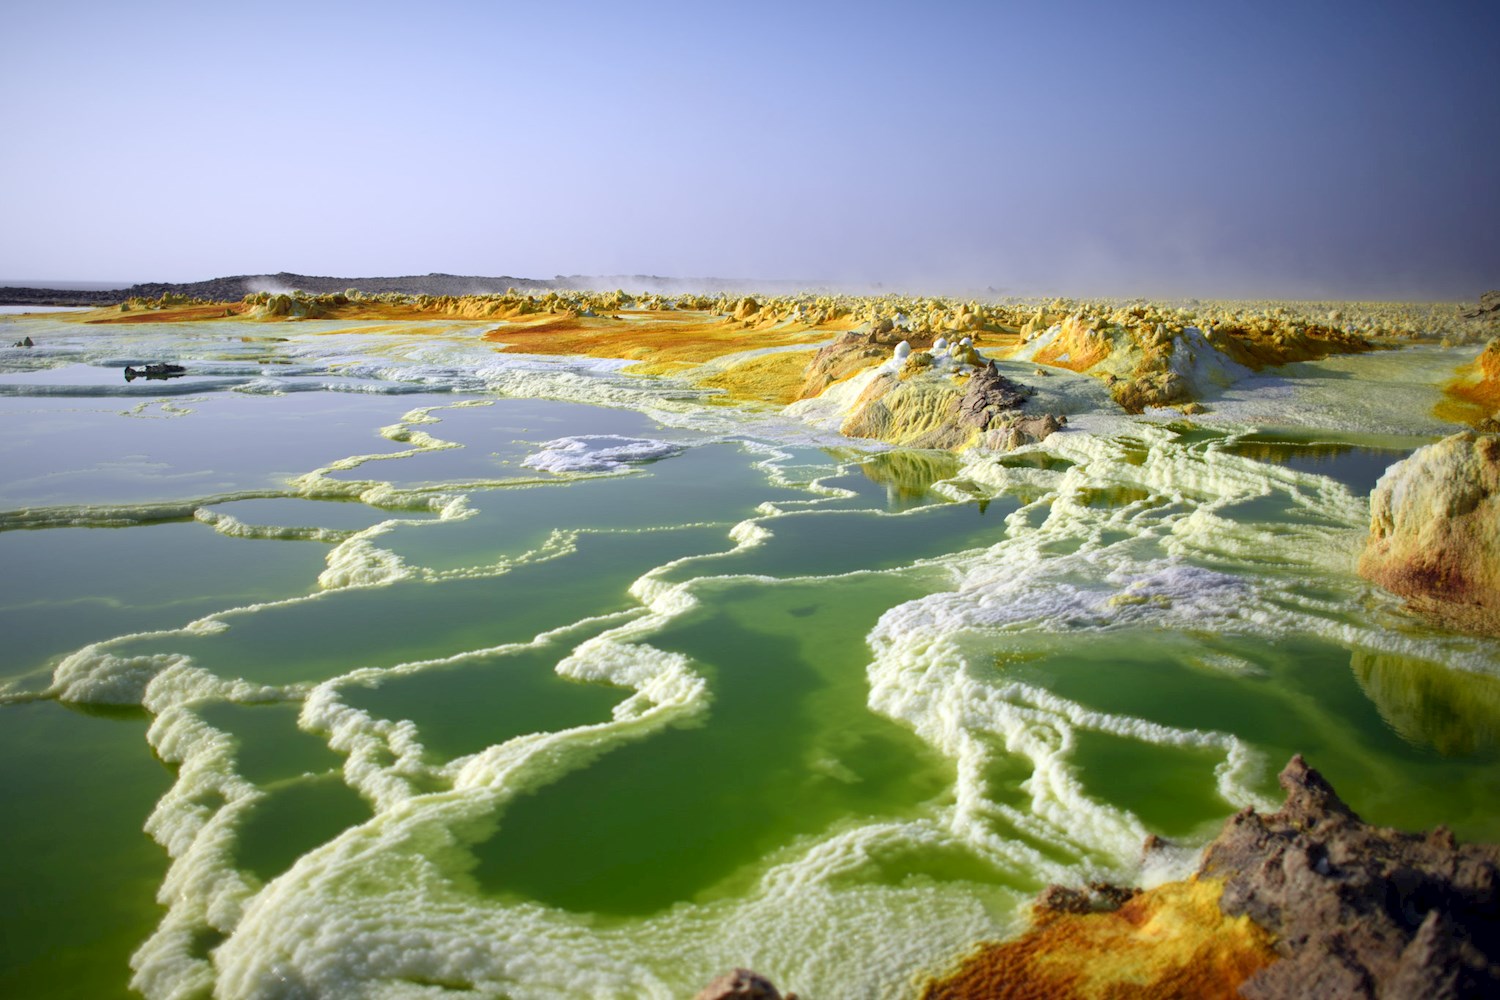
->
[1199,754,1500,1000]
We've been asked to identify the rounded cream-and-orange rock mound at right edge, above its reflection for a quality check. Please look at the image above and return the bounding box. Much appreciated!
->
[1359,432,1500,634]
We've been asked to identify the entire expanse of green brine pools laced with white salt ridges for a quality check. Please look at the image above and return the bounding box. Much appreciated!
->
[0,318,1500,1000]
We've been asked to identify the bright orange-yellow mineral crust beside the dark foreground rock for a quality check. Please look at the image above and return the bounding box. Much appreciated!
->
[923,879,1277,1000]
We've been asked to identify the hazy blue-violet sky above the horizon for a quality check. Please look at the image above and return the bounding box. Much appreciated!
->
[0,0,1500,301]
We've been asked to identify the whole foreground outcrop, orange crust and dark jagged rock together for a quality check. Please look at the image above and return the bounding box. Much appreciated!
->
[924,756,1500,1000]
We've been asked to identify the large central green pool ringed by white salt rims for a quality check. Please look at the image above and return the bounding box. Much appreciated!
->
[476,580,951,915]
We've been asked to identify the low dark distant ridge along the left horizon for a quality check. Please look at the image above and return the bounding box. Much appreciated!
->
[0,271,821,306]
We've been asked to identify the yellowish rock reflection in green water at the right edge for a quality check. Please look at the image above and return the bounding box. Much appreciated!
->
[1349,651,1500,757]
